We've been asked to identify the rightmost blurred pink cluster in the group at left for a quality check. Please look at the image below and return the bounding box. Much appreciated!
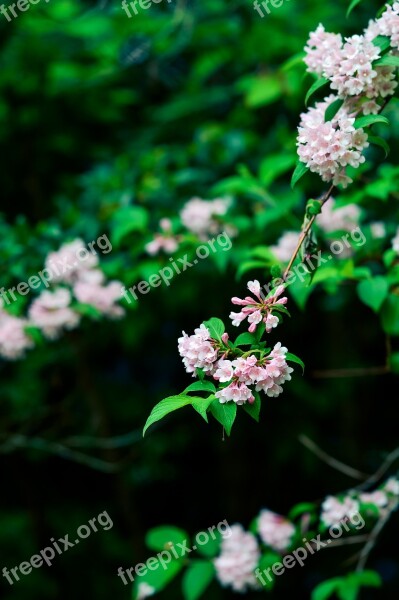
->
[73,269,125,318]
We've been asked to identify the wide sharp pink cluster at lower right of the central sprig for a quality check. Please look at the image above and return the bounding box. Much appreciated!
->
[213,342,293,404]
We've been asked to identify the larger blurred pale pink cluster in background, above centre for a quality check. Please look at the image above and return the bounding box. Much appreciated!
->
[180,198,234,240]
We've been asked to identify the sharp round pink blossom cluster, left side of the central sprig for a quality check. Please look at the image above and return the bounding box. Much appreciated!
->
[178,324,218,376]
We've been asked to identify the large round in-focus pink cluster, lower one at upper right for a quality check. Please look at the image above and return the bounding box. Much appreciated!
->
[297,95,369,187]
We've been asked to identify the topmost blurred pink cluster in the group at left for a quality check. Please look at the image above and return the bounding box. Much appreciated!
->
[45,239,99,283]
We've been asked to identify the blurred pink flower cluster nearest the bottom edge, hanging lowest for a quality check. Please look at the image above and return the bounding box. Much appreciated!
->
[214,524,260,592]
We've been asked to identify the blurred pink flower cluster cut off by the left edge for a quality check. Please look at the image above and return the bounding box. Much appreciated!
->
[0,304,33,360]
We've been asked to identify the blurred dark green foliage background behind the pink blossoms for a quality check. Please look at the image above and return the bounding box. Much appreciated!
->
[0,0,399,600]
